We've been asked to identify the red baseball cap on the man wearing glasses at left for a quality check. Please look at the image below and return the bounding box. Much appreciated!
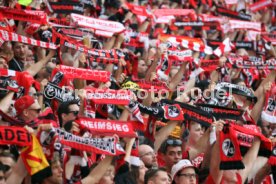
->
[14,95,41,115]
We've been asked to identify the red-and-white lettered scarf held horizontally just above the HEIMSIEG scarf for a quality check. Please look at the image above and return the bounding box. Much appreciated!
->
[85,88,131,105]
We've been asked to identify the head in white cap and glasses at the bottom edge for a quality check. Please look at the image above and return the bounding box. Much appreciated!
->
[171,159,197,184]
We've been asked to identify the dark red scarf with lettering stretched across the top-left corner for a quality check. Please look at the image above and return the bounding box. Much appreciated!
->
[0,7,47,24]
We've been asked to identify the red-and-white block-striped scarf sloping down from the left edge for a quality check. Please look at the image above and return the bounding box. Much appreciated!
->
[0,30,57,49]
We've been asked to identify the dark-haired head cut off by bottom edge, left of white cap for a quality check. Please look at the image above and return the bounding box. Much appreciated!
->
[145,168,171,184]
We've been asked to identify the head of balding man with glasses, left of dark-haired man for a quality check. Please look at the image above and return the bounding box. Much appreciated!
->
[139,144,157,169]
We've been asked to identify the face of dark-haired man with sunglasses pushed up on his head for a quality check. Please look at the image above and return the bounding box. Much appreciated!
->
[163,146,182,170]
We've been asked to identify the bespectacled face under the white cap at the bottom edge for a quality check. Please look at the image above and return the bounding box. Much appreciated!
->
[174,168,196,184]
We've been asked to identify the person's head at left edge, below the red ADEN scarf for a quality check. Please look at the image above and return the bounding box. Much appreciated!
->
[0,152,16,178]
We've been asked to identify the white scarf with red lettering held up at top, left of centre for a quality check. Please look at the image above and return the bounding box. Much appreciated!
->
[71,13,125,37]
